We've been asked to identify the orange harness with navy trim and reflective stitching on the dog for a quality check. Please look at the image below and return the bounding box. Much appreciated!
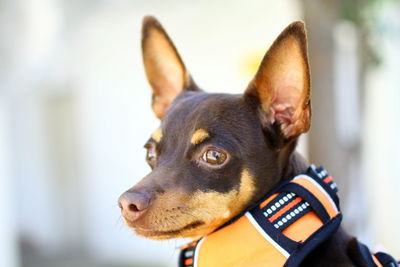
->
[179,165,396,267]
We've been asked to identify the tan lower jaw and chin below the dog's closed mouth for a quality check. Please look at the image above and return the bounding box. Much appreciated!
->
[126,221,207,240]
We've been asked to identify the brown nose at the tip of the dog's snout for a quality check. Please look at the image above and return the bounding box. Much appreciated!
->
[118,191,152,221]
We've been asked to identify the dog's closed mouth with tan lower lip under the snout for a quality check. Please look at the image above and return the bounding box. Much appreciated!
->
[126,221,205,240]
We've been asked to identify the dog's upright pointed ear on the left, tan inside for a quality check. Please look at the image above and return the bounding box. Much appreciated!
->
[142,16,197,119]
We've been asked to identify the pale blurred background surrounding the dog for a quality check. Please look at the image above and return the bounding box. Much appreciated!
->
[0,0,400,267]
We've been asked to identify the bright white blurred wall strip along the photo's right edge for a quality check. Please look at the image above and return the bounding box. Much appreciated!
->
[362,1,400,255]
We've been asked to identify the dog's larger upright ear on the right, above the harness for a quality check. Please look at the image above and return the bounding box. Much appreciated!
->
[245,21,311,140]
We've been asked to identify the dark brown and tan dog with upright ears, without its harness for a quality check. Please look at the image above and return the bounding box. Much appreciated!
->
[119,16,397,267]
